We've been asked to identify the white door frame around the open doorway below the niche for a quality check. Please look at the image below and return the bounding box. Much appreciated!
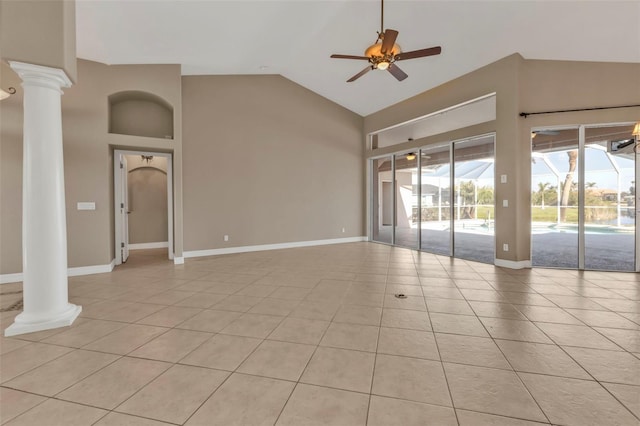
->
[113,149,175,265]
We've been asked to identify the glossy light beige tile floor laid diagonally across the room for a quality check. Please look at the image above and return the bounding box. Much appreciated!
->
[0,243,640,426]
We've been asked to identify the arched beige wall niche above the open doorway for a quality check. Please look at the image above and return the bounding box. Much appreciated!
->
[109,90,173,139]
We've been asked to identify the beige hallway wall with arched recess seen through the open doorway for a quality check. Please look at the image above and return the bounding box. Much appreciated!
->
[126,155,168,244]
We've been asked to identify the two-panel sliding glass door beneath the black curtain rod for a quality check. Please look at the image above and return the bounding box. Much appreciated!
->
[531,124,638,271]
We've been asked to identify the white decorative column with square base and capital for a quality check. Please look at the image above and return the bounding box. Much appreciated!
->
[4,62,82,336]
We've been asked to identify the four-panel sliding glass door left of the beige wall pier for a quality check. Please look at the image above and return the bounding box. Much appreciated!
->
[370,135,495,263]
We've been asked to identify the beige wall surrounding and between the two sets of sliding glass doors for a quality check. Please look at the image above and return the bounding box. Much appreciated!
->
[364,54,640,261]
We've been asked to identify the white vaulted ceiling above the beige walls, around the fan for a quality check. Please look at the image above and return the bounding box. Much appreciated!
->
[76,0,640,115]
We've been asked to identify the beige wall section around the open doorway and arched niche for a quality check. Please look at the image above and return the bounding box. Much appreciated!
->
[63,61,182,266]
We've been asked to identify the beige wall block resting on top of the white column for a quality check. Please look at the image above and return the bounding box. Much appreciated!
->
[0,0,77,82]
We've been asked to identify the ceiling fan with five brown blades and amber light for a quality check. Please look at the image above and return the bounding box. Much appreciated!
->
[331,0,442,83]
